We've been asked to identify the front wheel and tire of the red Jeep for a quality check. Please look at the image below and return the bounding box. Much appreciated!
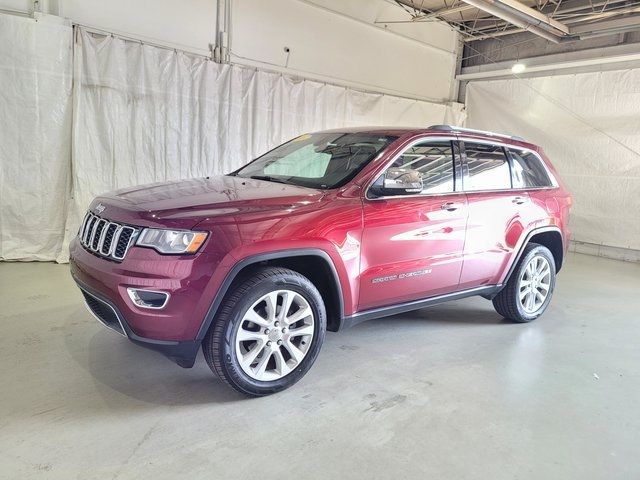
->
[202,267,327,396]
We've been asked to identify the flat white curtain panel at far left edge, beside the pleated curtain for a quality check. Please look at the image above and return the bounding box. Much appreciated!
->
[0,15,72,260]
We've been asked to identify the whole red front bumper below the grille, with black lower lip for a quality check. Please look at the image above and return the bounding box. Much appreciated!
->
[69,238,229,367]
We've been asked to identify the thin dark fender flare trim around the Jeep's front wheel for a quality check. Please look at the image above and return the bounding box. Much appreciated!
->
[196,248,344,342]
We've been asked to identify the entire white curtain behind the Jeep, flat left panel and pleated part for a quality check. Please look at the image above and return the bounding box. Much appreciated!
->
[0,14,464,262]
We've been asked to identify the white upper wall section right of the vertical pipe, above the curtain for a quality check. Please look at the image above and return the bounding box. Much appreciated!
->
[231,0,456,101]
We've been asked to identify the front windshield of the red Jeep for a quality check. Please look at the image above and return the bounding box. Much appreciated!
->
[235,133,397,189]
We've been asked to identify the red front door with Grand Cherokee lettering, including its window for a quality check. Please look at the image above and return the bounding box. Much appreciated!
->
[358,140,467,311]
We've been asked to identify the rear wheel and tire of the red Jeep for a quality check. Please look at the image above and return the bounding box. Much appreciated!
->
[493,243,556,323]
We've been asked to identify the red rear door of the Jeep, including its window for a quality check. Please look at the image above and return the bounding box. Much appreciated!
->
[460,140,533,289]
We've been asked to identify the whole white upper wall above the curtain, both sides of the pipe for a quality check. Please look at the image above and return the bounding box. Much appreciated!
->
[0,0,458,101]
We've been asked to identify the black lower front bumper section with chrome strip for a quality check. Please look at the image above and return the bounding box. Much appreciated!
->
[72,274,200,368]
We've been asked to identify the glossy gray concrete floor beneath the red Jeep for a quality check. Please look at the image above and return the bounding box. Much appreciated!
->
[0,255,640,480]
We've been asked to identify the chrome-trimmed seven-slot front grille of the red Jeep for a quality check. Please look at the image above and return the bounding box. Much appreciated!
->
[78,212,136,261]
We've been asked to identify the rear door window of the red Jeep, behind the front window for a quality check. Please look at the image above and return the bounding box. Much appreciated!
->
[464,142,511,191]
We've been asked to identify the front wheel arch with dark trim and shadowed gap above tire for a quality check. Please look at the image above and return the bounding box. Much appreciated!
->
[196,248,344,341]
